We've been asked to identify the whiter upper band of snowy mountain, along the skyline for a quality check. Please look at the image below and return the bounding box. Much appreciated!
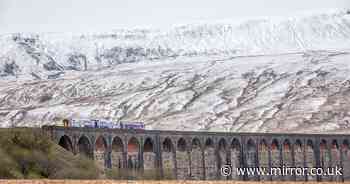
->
[0,11,350,79]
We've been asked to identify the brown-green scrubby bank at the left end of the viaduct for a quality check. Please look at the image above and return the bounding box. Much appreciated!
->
[0,128,99,179]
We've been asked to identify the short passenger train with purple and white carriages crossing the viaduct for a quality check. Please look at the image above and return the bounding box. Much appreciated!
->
[62,119,146,130]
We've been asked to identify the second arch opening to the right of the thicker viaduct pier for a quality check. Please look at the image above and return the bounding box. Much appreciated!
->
[176,137,190,179]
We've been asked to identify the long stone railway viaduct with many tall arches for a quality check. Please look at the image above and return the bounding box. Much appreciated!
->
[43,126,350,181]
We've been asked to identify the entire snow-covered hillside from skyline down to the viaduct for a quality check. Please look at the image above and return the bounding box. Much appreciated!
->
[0,11,350,132]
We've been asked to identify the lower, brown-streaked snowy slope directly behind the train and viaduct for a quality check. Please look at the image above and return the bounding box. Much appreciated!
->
[0,51,350,132]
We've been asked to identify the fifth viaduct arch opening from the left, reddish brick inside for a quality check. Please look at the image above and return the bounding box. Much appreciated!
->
[127,137,140,170]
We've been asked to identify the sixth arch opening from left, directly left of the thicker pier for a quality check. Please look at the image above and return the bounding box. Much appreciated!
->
[143,137,156,174]
